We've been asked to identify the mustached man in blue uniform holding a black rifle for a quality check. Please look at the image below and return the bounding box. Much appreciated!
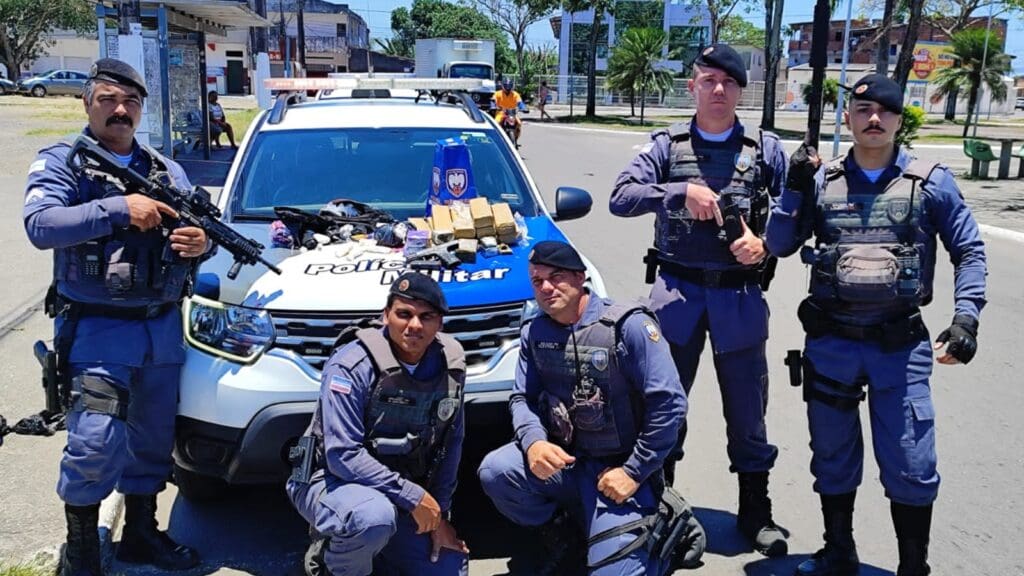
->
[24,58,207,575]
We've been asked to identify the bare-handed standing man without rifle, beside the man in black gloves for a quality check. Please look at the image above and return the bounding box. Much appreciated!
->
[609,44,786,556]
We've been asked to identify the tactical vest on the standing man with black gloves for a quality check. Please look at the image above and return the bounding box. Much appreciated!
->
[805,157,936,321]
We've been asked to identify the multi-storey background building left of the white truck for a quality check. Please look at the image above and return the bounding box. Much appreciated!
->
[266,0,370,77]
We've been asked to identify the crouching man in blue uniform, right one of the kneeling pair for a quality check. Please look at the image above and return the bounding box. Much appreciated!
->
[478,241,686,575]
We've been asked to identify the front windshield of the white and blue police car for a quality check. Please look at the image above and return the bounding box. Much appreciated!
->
[230,128,538,219]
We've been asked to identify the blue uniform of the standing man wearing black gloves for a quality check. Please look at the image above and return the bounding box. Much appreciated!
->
[767,150,986,502]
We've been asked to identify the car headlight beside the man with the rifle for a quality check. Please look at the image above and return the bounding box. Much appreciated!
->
[183,296,274,364]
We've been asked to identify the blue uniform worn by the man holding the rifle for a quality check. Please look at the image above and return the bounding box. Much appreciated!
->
[24,129,191,506]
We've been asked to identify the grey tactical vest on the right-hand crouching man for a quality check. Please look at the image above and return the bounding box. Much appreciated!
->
[530,296,649,461]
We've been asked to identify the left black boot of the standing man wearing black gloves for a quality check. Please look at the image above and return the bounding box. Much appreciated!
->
[796,492,860,576]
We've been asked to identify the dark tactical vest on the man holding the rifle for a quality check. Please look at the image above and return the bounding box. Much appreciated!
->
[54,147,195,305]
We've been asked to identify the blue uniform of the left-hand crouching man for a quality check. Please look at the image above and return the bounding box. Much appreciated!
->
[288,329,468,576]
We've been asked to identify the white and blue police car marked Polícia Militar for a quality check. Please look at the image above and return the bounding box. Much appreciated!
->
[174,78,605,499]
